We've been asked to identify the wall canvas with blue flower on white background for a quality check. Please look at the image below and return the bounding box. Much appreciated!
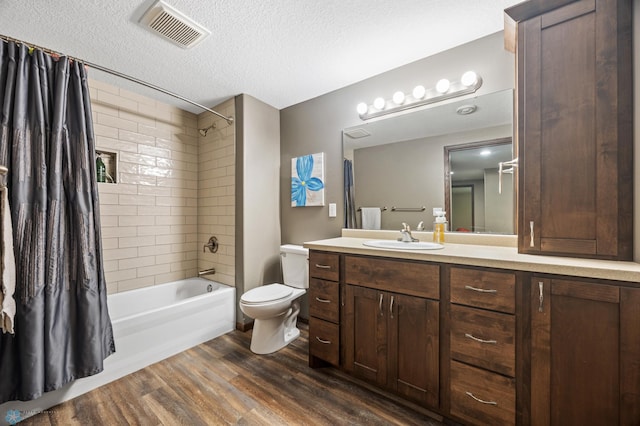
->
[291,152,324,207]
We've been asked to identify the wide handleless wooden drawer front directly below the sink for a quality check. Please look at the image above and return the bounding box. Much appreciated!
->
[344,256,440,300]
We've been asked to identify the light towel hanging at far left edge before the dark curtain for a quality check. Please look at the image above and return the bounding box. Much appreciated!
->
[0,187,16,334]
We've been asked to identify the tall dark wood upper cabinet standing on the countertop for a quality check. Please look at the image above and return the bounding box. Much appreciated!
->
[505,0,633,260]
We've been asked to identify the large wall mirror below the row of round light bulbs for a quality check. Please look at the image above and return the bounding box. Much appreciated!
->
[343,90,516,234]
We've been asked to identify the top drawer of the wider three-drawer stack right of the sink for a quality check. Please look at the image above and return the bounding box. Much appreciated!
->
[449,267,516,314]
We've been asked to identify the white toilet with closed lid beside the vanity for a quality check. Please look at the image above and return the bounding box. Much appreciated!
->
[240,244,309,354]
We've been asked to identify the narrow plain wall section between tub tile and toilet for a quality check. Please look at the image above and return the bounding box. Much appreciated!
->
[236,95,281,324]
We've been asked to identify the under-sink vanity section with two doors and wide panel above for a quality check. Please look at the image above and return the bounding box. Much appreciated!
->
[343,256,440,408]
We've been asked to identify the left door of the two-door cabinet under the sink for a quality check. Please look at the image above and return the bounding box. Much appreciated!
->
[344,285,389,386]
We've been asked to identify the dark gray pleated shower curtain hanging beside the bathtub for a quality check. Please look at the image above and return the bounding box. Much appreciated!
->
[0,41,115,402]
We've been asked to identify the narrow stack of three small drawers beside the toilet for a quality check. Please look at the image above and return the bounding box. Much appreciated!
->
[309,250,340,367]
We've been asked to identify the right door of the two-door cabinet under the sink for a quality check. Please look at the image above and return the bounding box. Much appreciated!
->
[387,294,440,407]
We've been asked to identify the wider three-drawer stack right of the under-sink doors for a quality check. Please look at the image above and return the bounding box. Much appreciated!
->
[449,266,516,425]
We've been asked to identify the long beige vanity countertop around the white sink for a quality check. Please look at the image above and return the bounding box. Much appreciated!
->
[304,233,640,283]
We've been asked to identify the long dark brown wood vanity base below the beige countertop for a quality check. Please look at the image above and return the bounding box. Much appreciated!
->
[309,250,640,426]
